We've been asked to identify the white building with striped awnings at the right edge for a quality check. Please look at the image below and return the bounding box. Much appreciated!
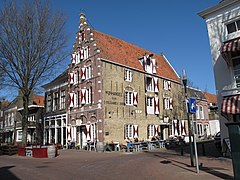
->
[199,0,240,149]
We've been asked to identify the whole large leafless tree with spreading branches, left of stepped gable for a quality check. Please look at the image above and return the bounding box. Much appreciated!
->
[0,0,68,145]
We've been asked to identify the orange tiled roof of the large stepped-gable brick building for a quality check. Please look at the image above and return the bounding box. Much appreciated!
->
[92,30,180,82]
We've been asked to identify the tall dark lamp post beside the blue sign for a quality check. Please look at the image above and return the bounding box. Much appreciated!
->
[182,69,194,167]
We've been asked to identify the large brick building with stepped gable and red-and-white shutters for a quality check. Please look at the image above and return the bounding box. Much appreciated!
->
[67,14,187,147]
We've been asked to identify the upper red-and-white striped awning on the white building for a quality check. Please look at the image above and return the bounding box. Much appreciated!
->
[221,38,240,63]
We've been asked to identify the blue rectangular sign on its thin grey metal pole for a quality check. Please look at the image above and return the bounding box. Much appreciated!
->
[189,98,199,173]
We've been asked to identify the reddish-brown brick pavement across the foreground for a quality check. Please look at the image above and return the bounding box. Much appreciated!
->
[0,149,233,180]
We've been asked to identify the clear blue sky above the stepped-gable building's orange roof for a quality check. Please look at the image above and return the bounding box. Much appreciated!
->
[0,0,220,100]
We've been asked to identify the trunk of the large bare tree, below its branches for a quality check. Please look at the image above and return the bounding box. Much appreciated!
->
[22,93,29,146]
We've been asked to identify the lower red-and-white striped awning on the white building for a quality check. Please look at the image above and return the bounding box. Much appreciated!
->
[222,95,240,114]
